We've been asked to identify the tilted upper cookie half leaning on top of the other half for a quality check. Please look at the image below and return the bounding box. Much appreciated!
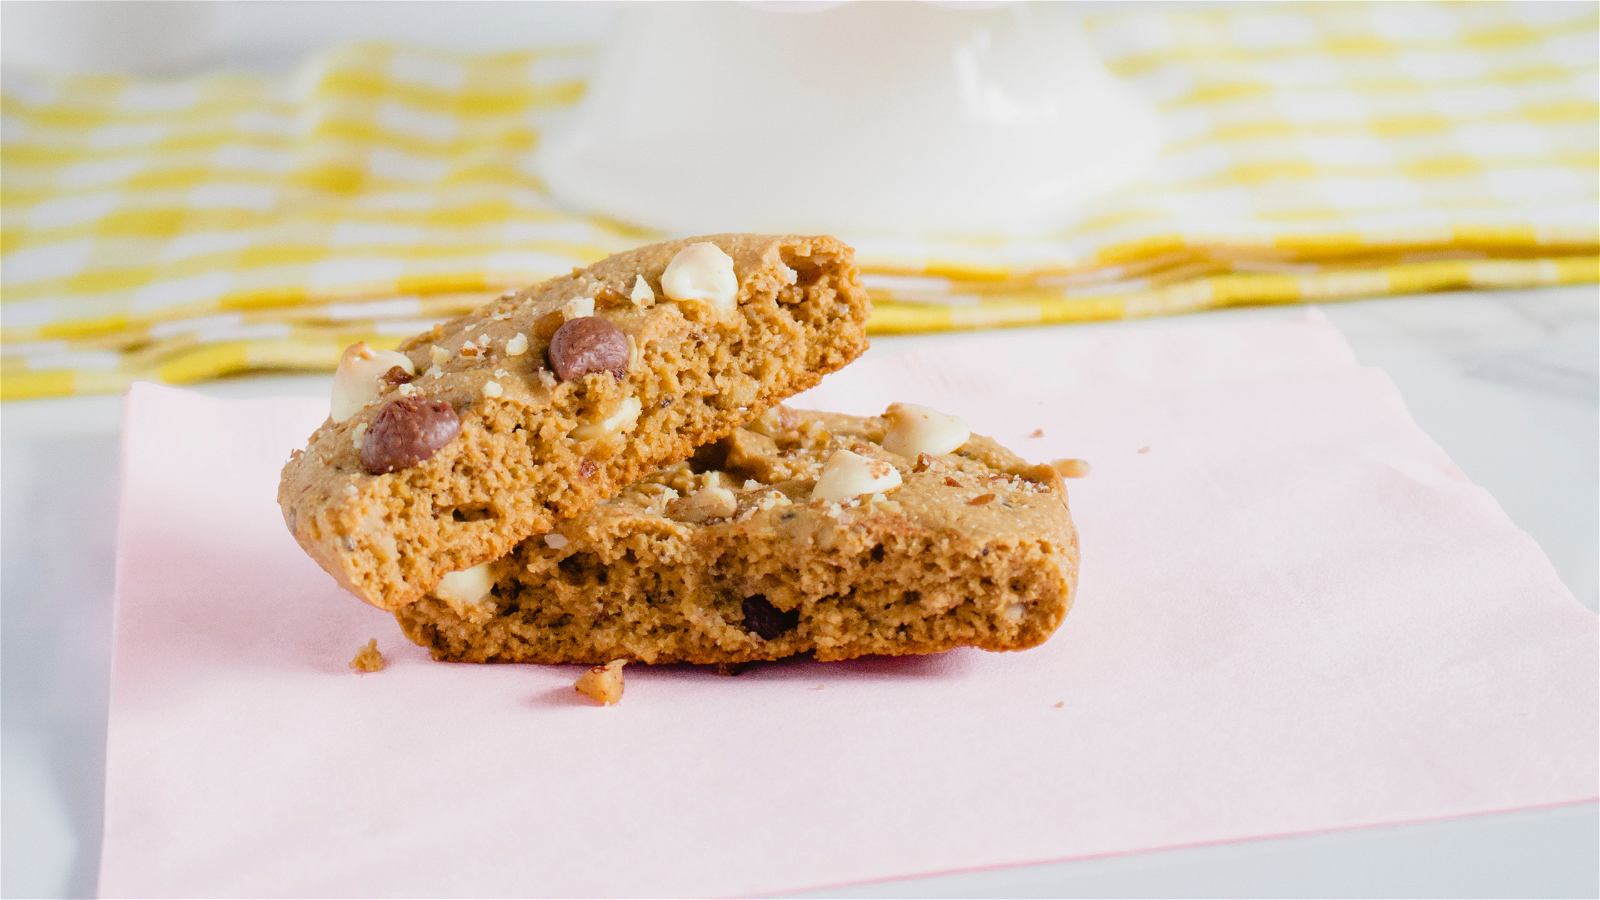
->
[278,234,870,610]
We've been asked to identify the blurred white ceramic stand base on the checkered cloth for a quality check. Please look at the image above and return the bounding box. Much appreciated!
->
[536,2,1160,235]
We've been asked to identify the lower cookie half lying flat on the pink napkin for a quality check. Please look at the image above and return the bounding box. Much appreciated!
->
[395,405,1078,665]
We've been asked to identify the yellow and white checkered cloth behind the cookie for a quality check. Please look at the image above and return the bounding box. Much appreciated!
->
[0,3,1600,399]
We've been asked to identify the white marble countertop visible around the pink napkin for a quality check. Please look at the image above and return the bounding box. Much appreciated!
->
[0,285,1600,897]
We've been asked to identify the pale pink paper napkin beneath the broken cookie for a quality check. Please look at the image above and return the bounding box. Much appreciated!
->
[101,315,1600,897]
